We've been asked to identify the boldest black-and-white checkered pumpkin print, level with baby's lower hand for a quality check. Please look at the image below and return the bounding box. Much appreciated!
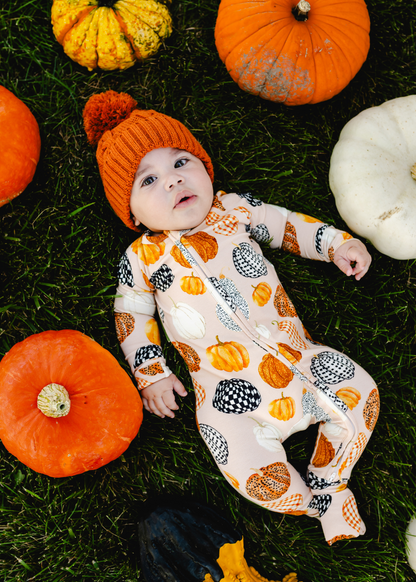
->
[212,378,261,414]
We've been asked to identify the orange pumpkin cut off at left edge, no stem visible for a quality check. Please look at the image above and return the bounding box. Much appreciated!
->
[0,85,40,206]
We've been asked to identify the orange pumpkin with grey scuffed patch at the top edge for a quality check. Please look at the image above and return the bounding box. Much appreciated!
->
[215,0,370,105]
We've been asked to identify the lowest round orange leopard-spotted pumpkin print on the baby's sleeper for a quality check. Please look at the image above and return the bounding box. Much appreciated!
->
[246,463,290,501]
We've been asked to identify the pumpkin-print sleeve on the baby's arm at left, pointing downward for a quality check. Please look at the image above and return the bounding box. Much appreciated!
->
[114,247,172,390]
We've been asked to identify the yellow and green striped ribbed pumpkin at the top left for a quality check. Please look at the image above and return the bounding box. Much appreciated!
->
[52,0,172,71]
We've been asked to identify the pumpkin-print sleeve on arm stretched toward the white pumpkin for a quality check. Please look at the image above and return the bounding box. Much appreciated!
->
[245,194,353,262]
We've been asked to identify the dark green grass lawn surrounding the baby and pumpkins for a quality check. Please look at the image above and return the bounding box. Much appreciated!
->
[0,0,416,582]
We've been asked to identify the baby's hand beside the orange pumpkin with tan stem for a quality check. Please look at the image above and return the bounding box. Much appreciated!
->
[140,374,188,418]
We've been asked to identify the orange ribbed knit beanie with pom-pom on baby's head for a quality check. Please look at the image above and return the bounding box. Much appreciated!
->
[83,91,214,230]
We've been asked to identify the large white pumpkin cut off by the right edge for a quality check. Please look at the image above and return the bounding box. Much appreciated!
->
[329,95,416,259]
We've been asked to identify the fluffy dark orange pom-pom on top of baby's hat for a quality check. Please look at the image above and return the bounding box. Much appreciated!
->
[82,91,137,146]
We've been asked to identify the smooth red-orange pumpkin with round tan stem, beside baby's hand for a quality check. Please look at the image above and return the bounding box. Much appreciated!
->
[0,330,143,477]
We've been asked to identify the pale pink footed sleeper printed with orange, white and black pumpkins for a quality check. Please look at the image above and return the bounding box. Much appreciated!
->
[116,194,378,540]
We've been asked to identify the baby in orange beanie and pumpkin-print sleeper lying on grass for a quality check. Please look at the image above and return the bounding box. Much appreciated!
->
[84,91,379,545]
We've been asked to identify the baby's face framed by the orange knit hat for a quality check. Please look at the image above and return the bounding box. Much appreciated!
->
[130,148,214,232]
